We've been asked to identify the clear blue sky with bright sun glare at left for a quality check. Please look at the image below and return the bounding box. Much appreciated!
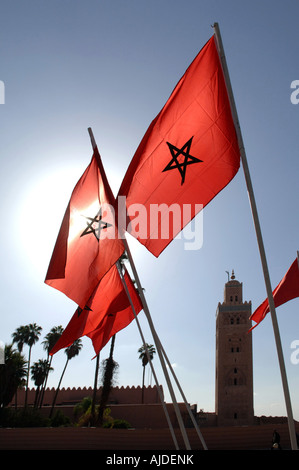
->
[0,0,299,420]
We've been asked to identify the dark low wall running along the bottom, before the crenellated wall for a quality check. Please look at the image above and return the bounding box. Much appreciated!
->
[0,424,299,452]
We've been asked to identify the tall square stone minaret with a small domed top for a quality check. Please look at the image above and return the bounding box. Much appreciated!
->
[215,271,254,426]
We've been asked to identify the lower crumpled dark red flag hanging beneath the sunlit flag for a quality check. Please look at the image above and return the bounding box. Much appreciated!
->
[50,265,142,356]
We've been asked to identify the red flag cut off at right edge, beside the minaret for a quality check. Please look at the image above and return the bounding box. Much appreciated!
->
[250,258,299,330]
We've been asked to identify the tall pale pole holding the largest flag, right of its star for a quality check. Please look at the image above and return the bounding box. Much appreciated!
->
[214,23,298,450]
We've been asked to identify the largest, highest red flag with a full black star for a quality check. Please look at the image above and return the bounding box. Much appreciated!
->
[118,37,240,256]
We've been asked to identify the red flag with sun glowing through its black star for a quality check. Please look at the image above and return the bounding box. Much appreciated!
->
[45,148,124,308]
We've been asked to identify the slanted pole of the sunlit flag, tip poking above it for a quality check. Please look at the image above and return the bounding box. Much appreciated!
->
[88,127,191,450]
